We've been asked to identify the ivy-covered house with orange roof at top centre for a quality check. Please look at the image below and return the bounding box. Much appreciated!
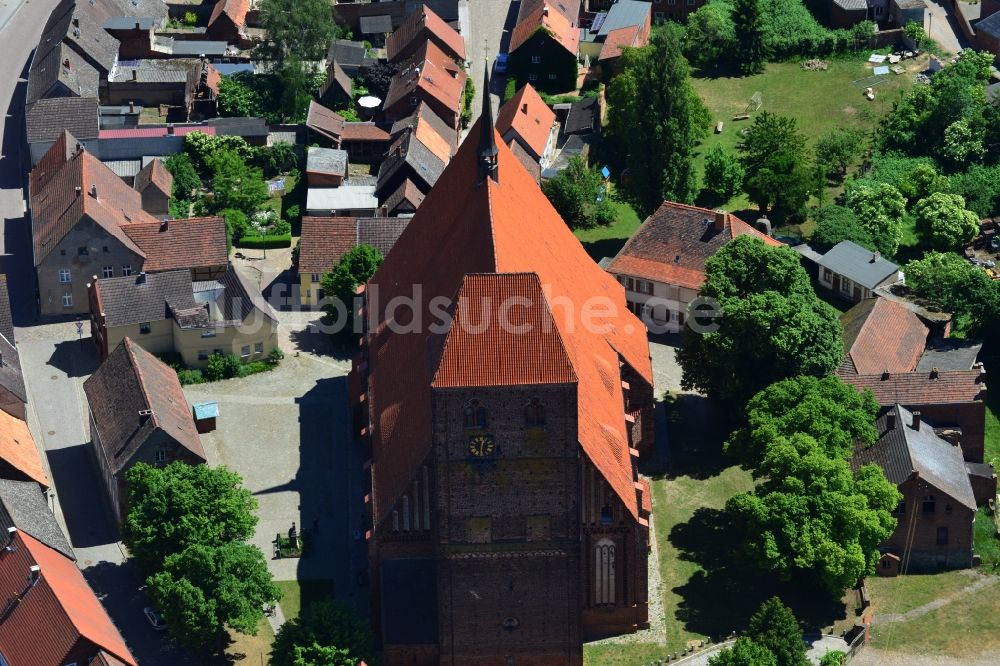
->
[508,0,580,92]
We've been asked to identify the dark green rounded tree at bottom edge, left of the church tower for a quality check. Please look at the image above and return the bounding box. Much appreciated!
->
[271,601,374,666]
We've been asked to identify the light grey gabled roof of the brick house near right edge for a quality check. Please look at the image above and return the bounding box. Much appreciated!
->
[851,404,976,511]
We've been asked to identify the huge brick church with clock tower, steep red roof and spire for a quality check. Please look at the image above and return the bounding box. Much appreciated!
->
[349,94,653,666]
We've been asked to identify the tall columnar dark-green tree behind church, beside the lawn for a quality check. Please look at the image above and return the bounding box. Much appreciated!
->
[608,26,709,213]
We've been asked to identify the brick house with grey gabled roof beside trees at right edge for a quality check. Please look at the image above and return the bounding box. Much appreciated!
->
[852,404,976,575]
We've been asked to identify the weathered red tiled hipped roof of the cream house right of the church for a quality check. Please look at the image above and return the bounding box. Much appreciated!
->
[608,201,781,289]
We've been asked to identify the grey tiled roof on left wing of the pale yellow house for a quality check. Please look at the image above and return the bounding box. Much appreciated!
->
[97,270,198,327]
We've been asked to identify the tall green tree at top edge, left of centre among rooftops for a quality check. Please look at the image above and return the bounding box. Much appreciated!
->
[255,0,341,71]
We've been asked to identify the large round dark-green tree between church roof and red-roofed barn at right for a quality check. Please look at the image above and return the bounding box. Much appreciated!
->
[678,236,843,403]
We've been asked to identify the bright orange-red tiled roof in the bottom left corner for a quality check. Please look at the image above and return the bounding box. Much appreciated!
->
[0,530,136,666]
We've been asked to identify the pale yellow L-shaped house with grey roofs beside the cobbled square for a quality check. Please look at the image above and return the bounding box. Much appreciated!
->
[90,266,278,368]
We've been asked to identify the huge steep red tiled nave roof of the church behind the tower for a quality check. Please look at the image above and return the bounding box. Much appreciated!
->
[368,121,652,521]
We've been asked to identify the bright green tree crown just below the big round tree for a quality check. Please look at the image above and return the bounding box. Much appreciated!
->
[725,375,878,471]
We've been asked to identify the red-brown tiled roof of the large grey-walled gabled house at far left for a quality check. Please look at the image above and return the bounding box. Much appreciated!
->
[29,132,157,266]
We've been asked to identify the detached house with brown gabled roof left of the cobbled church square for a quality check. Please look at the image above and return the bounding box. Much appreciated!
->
[83,338,206,520]
